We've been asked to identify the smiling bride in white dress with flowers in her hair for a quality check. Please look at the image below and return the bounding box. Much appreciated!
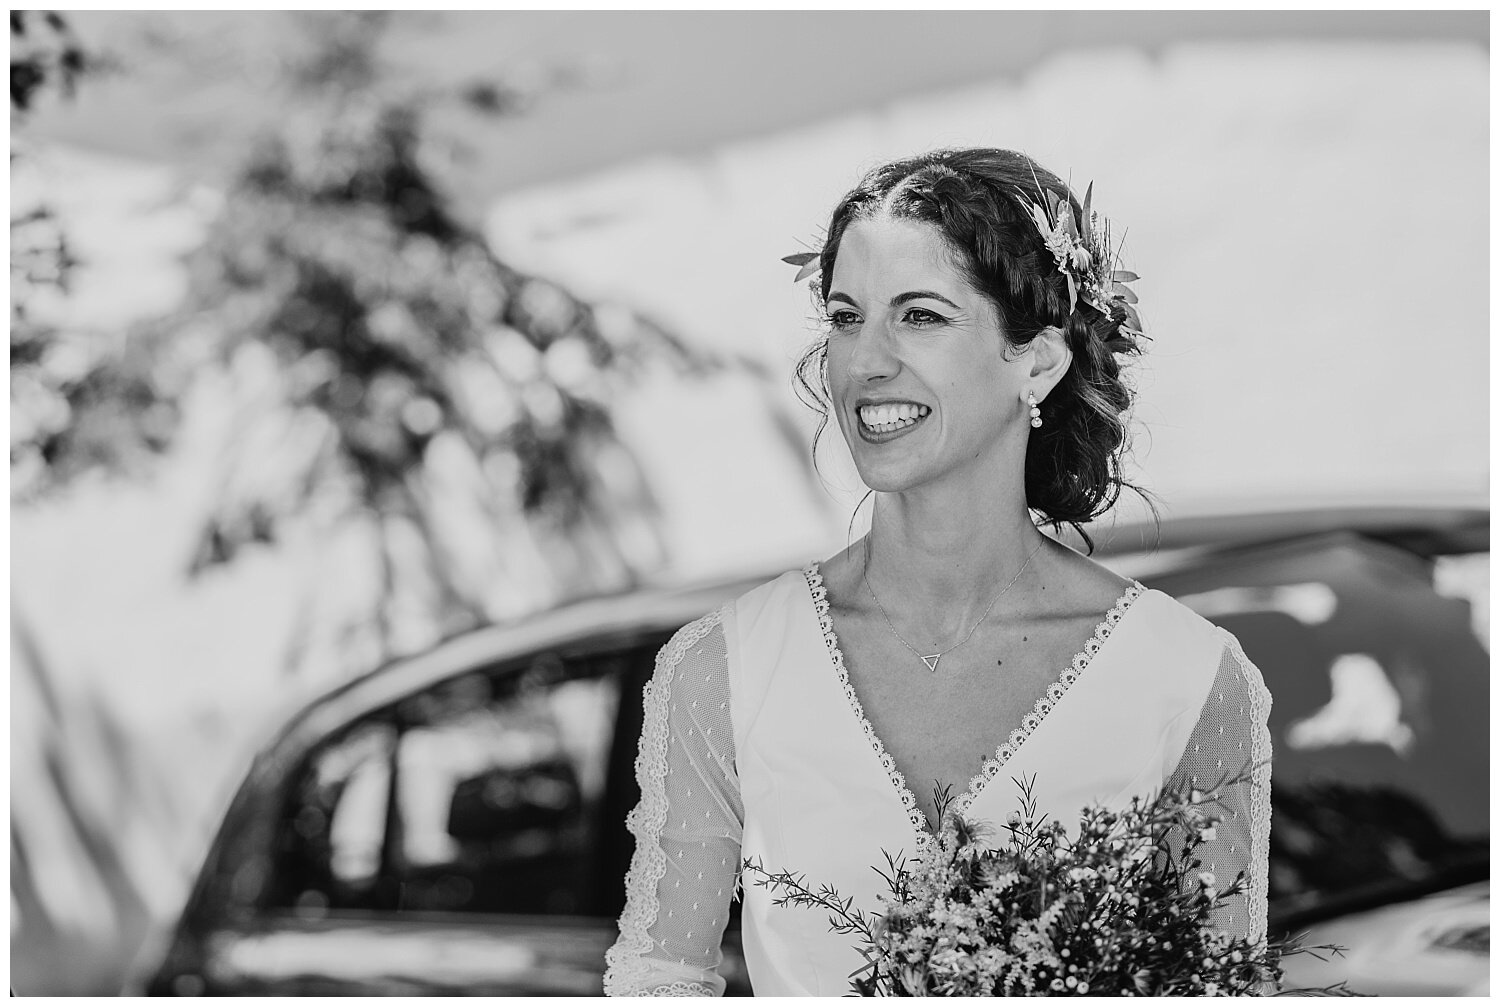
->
[605,149,1271,995]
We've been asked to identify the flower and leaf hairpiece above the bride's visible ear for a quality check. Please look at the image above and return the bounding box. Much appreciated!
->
[1020,182,1143,338]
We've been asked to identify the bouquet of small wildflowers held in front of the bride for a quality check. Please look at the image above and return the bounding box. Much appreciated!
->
[744,780,1346,996]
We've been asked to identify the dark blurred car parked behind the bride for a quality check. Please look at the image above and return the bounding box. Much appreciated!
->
[143,507,1490,995]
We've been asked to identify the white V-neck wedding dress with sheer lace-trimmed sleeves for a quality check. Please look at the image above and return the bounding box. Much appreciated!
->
[605,566,1271,996]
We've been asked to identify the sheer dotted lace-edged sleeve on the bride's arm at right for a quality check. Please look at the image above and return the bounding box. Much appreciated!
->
[1169,630,1271,939]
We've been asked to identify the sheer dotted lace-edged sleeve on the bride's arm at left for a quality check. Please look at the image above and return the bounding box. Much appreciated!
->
[605,611,744,996]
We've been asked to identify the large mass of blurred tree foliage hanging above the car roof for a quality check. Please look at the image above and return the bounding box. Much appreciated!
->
[12,12,786,660]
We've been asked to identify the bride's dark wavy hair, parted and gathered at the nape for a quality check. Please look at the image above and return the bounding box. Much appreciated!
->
[797,149,1149,549]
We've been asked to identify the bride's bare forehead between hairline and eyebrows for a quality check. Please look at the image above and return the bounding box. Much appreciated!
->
[833,216,969,294]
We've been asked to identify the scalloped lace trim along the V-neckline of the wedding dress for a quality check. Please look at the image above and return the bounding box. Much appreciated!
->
[803,563,1148,857]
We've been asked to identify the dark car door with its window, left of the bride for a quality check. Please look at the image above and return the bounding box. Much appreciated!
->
[156,639,744,995]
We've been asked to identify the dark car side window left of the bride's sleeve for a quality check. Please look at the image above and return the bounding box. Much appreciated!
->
[272,648,653,915]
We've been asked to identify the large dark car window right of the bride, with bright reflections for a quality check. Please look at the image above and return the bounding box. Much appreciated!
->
[1157,536,1490,911]
